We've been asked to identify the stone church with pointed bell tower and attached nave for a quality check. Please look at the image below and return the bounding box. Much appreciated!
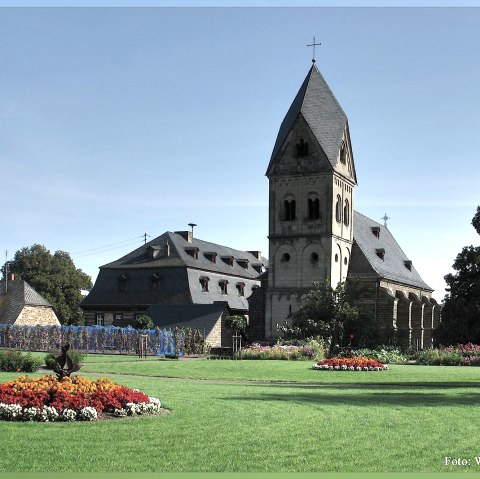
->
[265,62,440,348]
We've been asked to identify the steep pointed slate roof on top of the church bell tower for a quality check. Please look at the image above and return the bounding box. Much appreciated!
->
[267,64,347,172]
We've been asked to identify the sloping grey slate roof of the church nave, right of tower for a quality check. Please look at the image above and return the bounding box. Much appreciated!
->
[348,211,433,291]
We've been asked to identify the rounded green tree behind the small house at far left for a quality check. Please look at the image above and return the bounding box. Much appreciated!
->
[3,244,92,324]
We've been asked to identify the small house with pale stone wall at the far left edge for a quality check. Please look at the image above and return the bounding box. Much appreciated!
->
[0,275,60,326]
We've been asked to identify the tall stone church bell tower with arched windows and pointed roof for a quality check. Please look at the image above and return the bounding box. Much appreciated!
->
[265,63,357,338]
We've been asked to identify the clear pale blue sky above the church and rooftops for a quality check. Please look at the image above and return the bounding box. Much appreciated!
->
[0,8,480,299]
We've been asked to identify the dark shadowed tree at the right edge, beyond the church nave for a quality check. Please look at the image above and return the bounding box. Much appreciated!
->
[434,206,480,345]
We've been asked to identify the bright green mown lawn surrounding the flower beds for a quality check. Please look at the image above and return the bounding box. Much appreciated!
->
[0,355,480,472]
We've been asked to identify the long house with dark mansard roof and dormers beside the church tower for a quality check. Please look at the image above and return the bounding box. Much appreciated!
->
[80,231,267,347]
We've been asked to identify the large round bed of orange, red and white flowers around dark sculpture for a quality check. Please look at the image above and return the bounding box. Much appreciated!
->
[0,375,162,422]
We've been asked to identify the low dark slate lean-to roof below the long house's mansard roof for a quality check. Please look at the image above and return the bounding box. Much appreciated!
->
[145,302,228,335]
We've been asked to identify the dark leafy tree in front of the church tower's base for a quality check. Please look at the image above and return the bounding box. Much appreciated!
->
[279,278,375,352]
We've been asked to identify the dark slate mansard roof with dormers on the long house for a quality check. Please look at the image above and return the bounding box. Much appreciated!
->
[80,232,267,310]
